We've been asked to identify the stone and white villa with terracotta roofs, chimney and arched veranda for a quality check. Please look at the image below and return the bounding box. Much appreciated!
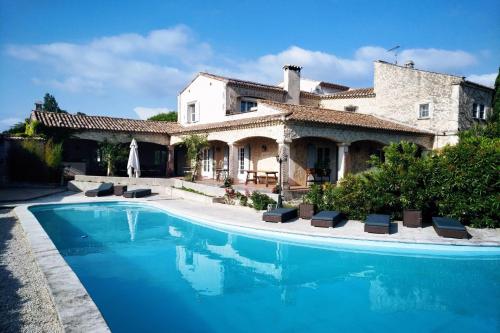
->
[33,61,493,189]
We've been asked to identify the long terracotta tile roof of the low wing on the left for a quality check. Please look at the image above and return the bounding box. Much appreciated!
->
[31,111,180,134]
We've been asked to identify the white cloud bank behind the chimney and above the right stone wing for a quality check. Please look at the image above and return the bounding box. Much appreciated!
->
[228,46,477,85]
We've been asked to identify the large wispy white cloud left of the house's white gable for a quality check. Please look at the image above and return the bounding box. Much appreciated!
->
[7,26,205,97]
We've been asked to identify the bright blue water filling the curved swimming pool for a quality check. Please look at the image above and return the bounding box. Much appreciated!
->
[31,203,500,333]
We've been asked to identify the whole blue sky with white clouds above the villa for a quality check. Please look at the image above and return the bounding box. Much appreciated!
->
[0,0,500,130]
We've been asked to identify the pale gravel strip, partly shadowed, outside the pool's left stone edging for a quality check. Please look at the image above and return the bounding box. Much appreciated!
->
[0,209,63,333]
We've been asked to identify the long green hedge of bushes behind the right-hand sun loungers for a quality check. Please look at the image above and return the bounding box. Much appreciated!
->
[305,125,500,228]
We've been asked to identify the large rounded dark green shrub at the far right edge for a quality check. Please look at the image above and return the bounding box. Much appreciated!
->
[431,133,500,228]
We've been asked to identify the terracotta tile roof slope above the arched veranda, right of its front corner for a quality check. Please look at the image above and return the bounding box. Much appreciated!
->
[260,100,433,135]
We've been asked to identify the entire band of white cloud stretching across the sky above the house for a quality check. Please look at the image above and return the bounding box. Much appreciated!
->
[3,25,486,99]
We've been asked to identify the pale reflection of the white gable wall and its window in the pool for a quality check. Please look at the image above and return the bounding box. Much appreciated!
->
[175,246,224,296]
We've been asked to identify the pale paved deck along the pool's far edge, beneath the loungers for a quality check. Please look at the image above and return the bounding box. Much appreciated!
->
[16,192,500,246]
